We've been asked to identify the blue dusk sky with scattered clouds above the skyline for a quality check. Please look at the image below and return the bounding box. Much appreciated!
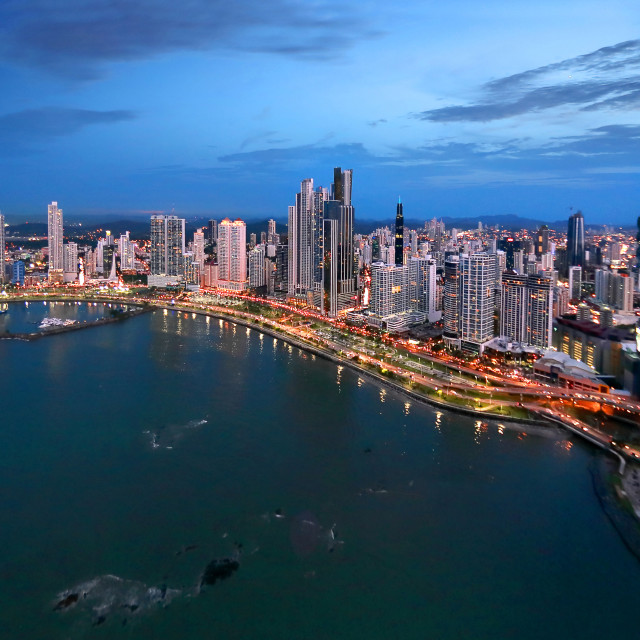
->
[0,0,640,224]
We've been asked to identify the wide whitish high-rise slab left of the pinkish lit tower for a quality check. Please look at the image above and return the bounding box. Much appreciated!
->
[149,215,185,286]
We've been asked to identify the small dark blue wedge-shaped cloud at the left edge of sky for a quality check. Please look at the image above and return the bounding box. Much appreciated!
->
[0,107,136,155]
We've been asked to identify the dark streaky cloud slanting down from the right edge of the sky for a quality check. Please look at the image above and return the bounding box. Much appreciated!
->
[414,40,640,122]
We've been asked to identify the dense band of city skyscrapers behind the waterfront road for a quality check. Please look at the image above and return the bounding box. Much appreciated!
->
[0,167,640,396]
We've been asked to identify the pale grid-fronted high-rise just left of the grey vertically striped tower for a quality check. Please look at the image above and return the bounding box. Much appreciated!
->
[460,253,495,350]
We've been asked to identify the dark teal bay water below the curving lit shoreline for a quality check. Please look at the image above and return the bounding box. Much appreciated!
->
[0,308,640,639]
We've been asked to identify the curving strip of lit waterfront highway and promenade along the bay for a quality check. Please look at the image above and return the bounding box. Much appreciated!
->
[7,290,640,471]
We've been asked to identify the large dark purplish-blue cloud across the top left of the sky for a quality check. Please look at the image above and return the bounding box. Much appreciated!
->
[0,0,373,79]
